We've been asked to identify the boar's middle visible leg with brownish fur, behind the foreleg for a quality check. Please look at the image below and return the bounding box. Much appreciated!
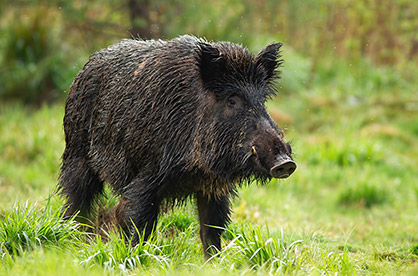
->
[115,179,161,244]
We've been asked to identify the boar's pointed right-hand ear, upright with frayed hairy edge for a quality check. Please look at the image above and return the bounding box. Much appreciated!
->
[255,42,283,81]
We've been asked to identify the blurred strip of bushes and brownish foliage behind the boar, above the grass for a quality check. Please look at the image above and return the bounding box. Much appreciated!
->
[0,0,418,103]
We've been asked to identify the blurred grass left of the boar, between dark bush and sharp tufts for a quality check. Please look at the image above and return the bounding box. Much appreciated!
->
[0,104,64,209]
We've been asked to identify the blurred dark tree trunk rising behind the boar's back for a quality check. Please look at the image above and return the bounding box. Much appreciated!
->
[128,0,158,39]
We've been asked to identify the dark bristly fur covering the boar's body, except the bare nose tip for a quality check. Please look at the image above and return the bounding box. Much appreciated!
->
[59,36,291,257]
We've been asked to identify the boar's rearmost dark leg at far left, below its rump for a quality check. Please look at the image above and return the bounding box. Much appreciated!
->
[59,157,103,218]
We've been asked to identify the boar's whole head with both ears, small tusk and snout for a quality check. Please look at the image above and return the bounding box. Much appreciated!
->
[198,42,296,183]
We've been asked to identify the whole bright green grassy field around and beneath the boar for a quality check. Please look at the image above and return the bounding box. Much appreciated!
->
[0,55,418,275]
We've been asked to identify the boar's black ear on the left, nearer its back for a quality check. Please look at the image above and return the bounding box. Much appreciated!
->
[199,42,225,83]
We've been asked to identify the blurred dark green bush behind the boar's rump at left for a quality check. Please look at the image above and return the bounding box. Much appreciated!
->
[0,7,79,105]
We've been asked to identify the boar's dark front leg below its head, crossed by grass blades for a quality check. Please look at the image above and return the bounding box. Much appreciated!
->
[197,194,231,259]
